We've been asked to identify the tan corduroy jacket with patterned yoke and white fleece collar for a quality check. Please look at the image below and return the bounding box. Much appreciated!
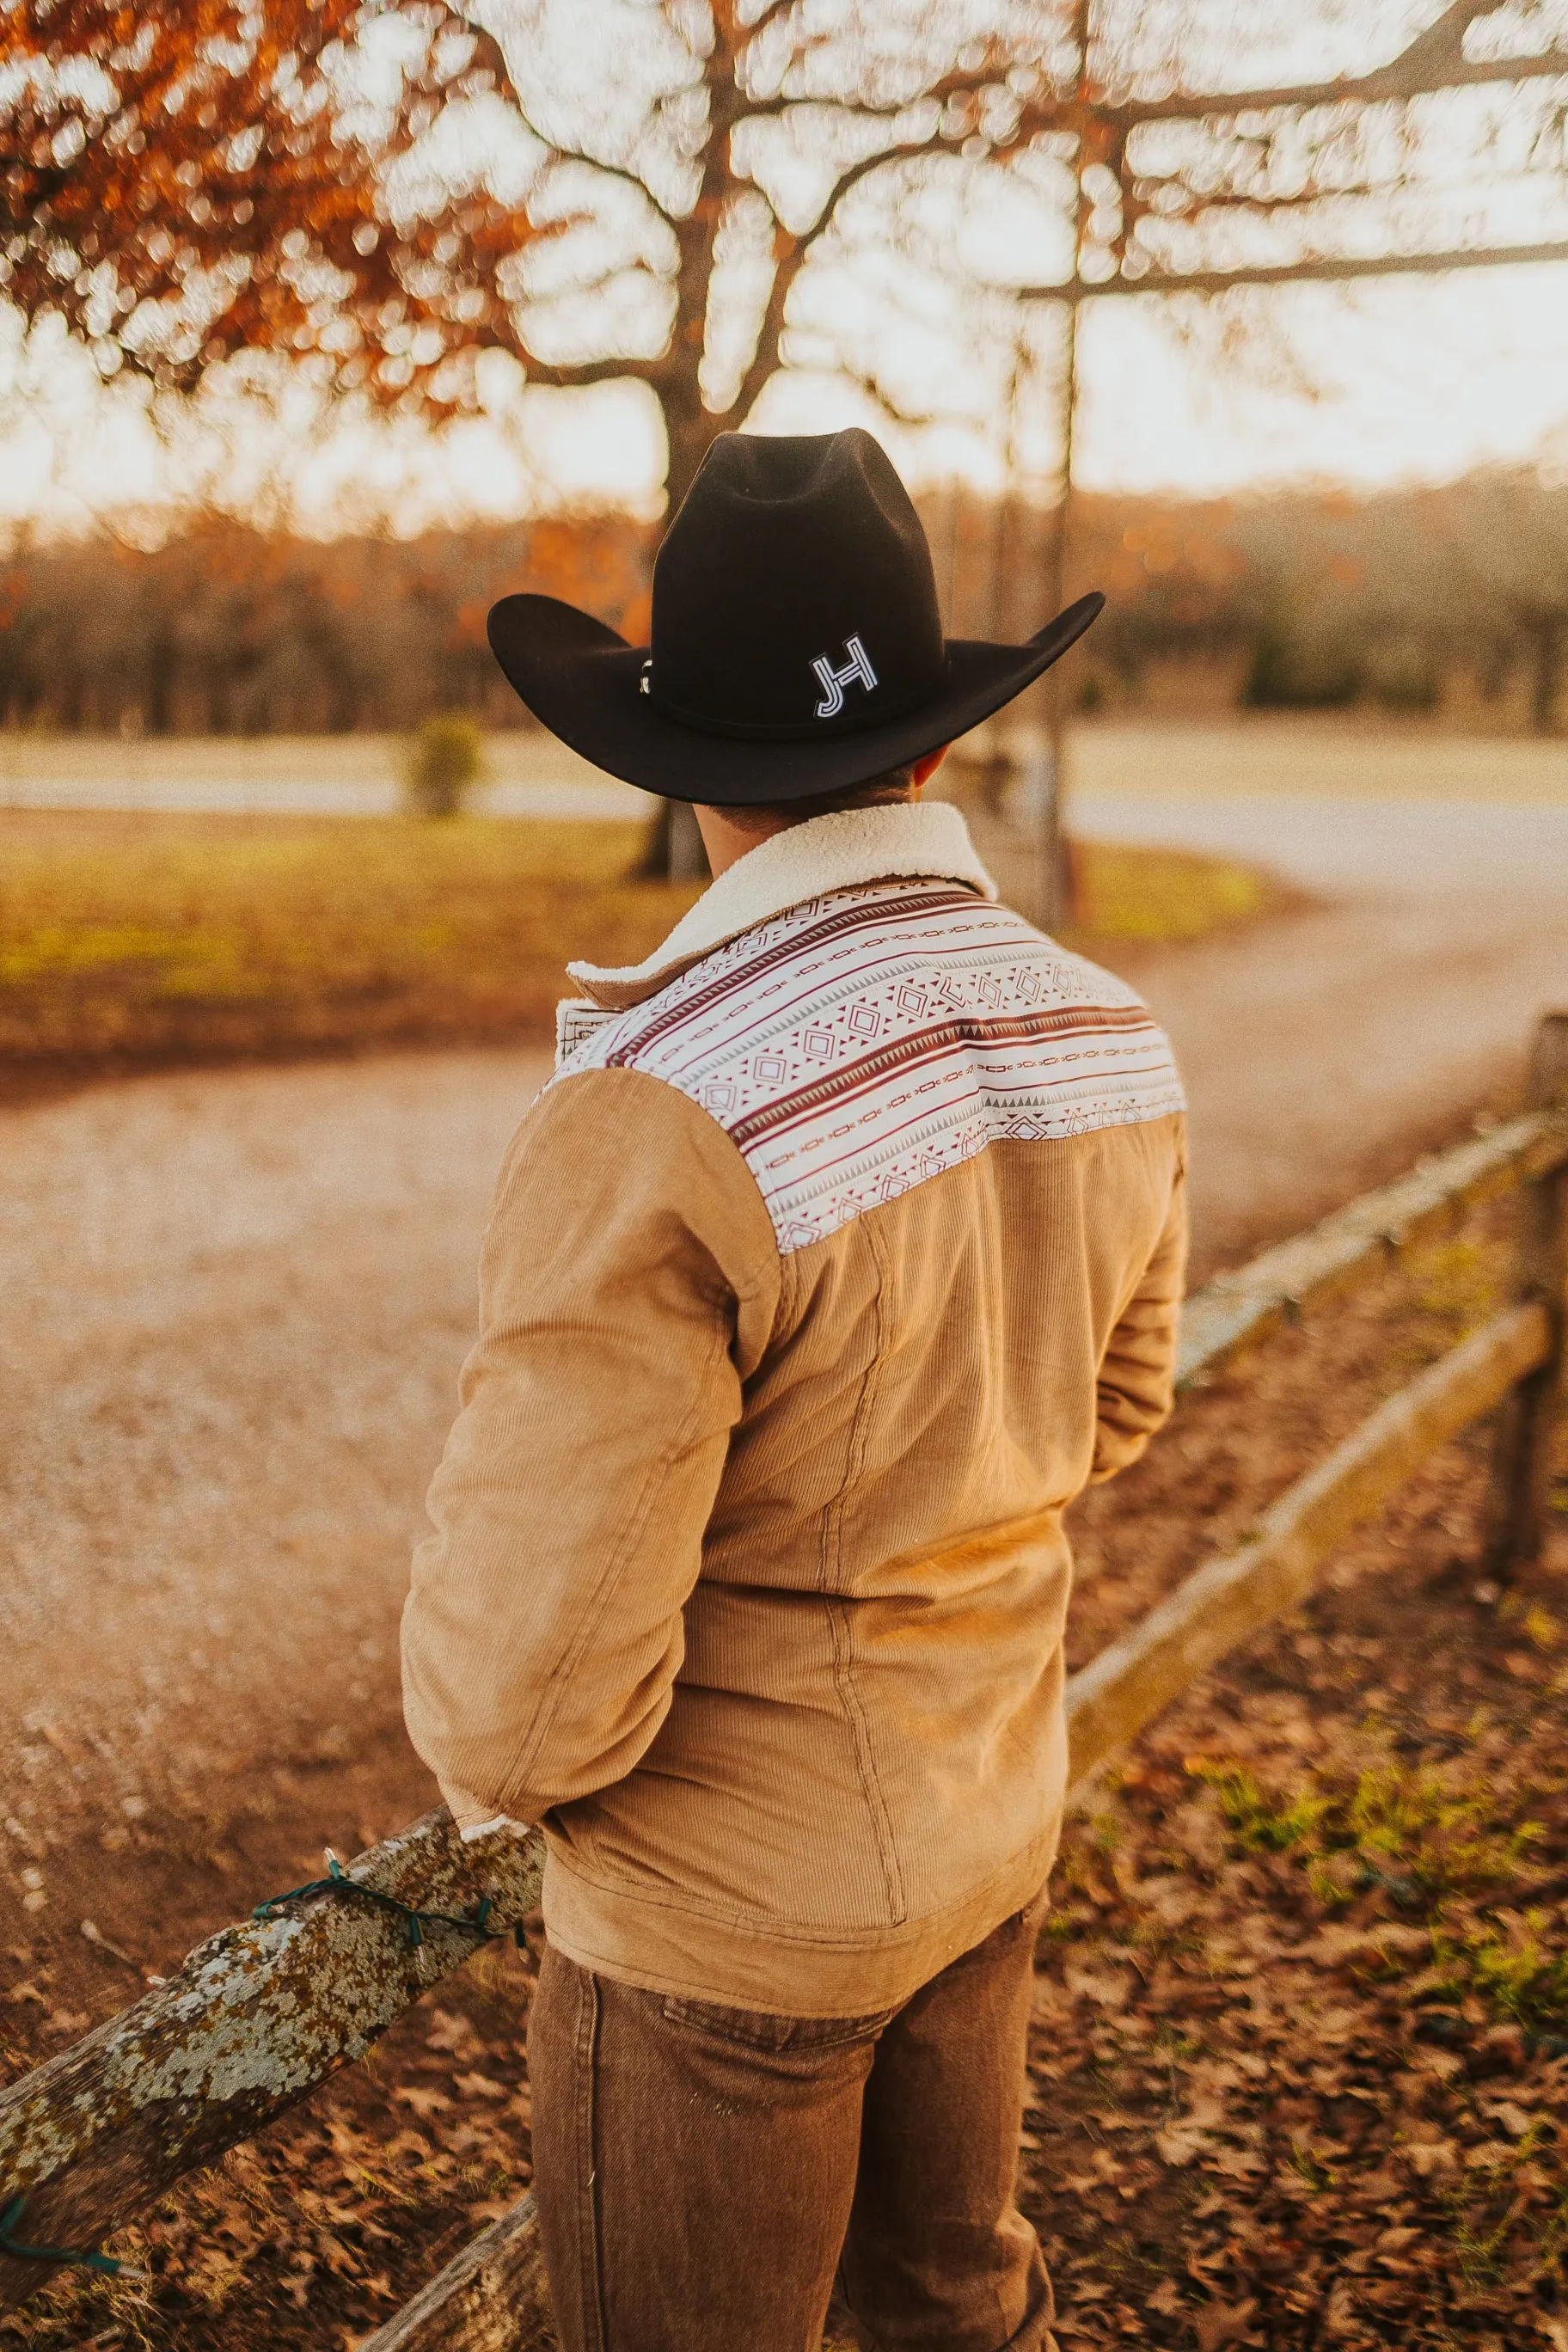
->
[404,805,1185,2016]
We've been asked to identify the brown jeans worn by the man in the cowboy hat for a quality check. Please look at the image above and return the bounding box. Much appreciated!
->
[529,1905,1056,2352]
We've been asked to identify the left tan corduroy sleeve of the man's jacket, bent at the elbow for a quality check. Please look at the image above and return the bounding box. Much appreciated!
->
[402,1070,778,1830]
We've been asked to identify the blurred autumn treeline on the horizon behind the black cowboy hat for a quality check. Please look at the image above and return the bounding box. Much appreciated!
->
[0,470,1568,734]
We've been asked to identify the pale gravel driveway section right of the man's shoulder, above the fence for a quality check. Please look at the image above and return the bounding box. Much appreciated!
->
[1090,785,1568,1277]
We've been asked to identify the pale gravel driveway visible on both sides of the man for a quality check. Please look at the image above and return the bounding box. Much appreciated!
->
[0,795,1568,1881]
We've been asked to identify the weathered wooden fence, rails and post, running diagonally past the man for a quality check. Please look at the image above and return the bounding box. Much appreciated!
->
[0,1014,1568,2352]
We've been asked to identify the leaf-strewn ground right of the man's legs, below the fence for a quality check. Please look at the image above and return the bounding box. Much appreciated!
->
[1025,1401,1568,2352]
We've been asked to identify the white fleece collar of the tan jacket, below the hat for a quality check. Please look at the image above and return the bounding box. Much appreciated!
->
[567,799,996,1011]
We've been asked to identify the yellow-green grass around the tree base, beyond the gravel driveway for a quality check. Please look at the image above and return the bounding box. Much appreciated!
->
[0,809,1271,1087]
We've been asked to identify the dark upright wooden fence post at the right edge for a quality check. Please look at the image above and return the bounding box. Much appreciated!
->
[1485,1011,1568,1583]
